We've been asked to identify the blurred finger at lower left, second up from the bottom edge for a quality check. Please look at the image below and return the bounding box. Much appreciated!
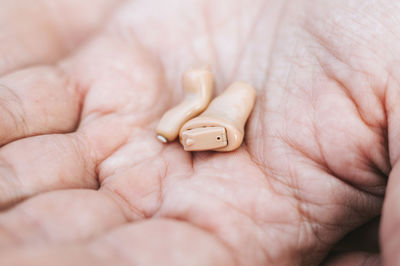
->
[0,189,126,249]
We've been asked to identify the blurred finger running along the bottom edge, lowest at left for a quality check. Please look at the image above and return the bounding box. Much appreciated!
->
[0,220,235,266]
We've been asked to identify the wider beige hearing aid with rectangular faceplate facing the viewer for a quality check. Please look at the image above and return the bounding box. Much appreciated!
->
[179,82,256,151]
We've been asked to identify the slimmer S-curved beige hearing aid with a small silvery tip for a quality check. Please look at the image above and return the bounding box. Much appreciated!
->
[156,67,214,143]
